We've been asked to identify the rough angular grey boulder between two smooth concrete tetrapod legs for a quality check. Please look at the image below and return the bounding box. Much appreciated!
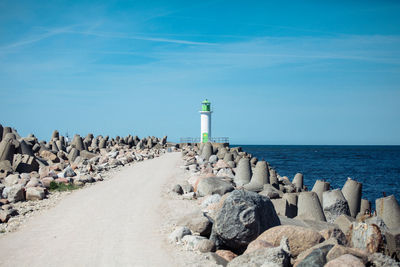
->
[322,189,350,223]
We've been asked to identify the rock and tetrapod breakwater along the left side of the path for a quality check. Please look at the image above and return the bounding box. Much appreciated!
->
[0,124,170,233]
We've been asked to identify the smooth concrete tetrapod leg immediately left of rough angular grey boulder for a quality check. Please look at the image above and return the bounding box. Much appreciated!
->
[297,192,326,221]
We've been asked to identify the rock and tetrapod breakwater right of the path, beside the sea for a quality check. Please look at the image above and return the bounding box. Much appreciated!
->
[169,143,400,266]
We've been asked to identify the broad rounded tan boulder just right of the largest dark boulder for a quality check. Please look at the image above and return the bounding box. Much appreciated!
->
[256,225,324,257]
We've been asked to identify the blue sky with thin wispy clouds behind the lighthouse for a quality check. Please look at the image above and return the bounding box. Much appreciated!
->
[0,0,400,145]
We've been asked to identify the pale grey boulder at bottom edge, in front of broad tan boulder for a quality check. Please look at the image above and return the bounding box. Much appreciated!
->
[227,238,291,267]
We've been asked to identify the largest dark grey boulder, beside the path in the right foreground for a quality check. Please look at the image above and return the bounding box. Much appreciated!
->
[210,190,280,253]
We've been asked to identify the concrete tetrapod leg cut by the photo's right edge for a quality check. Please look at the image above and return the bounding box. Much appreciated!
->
[375,195,400,229]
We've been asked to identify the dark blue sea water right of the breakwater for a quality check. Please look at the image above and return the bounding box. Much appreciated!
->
[240,145,400,206]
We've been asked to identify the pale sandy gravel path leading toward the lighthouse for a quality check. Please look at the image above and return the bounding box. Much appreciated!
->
[0,153,180,266]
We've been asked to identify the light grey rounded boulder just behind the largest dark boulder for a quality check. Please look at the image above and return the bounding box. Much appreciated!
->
[197,177,234,196]
